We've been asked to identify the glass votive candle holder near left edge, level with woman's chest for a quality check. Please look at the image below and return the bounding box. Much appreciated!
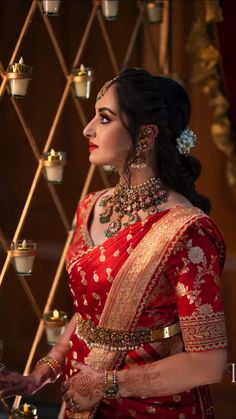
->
[11,240,37,276]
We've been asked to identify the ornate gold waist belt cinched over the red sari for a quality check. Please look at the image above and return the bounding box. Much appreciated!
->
[75,315,181,351]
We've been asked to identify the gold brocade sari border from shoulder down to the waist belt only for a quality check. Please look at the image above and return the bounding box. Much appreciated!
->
[101,207,205,330]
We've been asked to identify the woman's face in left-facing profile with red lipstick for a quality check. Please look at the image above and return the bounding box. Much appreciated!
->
[83,85,132,168]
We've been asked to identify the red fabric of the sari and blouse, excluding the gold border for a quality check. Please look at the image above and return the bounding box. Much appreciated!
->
[64,194,226,419]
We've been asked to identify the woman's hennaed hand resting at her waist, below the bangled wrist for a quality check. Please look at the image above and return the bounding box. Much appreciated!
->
[62,361,104,413]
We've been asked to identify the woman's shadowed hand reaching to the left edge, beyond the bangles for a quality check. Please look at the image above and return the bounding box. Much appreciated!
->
[0,364,48,398]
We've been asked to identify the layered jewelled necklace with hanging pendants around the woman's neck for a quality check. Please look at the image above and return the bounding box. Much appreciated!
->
[99,177,168,238]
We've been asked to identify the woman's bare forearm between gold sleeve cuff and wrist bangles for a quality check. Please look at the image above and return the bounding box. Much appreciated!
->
[117,349,226,397]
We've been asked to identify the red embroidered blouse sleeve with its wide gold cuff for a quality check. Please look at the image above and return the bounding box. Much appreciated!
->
[168,226,227,351]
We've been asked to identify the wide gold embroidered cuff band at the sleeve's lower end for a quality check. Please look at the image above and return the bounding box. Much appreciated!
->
[180,310,227,351]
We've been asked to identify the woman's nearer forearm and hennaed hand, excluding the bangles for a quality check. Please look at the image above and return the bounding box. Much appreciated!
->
[63,349,226,412]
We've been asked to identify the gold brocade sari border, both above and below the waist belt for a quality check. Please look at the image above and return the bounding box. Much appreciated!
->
[85,207,207,371]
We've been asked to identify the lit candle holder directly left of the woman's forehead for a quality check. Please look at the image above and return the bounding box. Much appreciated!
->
[72,64,94,99]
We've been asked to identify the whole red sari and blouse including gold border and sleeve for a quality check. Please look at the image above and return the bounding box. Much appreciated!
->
[64,191,227,419]
